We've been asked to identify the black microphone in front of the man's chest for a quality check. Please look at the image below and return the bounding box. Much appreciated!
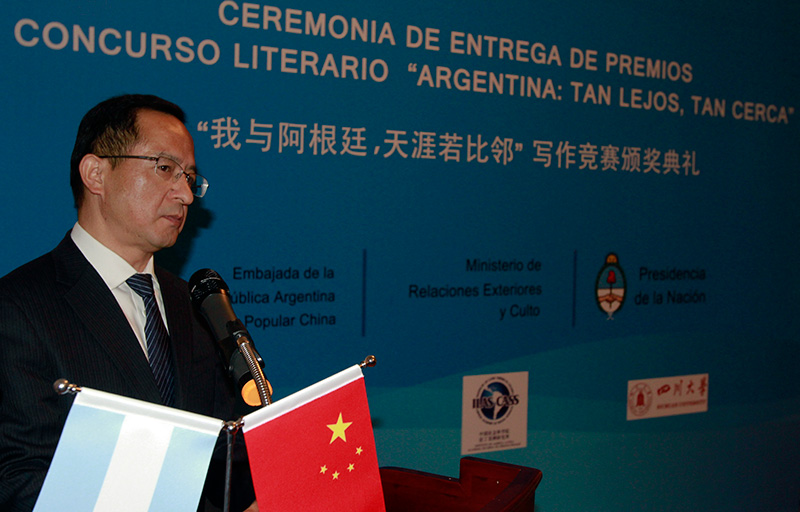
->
[189,268,272,407]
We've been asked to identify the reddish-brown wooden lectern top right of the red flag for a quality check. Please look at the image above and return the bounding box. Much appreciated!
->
[380,457,542,512]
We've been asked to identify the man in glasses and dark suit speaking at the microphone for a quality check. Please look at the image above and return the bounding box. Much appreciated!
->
[0,95,257,511]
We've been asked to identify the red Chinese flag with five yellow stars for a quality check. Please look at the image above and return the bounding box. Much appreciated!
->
[244,365,386,512]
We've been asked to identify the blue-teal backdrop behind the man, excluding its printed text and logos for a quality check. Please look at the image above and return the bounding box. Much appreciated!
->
[0,0,800,512]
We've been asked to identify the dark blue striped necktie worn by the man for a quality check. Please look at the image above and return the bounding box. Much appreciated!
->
[125,274,175,406]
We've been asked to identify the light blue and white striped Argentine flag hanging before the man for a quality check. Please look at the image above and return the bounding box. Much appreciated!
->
[34,388,224,512]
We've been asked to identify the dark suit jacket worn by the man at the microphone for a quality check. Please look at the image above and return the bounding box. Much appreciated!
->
[0,234,252,511]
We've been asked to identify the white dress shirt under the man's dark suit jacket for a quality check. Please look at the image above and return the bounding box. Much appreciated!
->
[70,222,169,356]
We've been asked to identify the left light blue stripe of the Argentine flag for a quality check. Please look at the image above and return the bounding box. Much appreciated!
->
[34,398,125,512]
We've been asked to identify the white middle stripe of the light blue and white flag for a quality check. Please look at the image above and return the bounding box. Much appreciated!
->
[94,415,173,512]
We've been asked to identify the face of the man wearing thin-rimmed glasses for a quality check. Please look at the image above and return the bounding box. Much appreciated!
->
[101,110,195,261]
